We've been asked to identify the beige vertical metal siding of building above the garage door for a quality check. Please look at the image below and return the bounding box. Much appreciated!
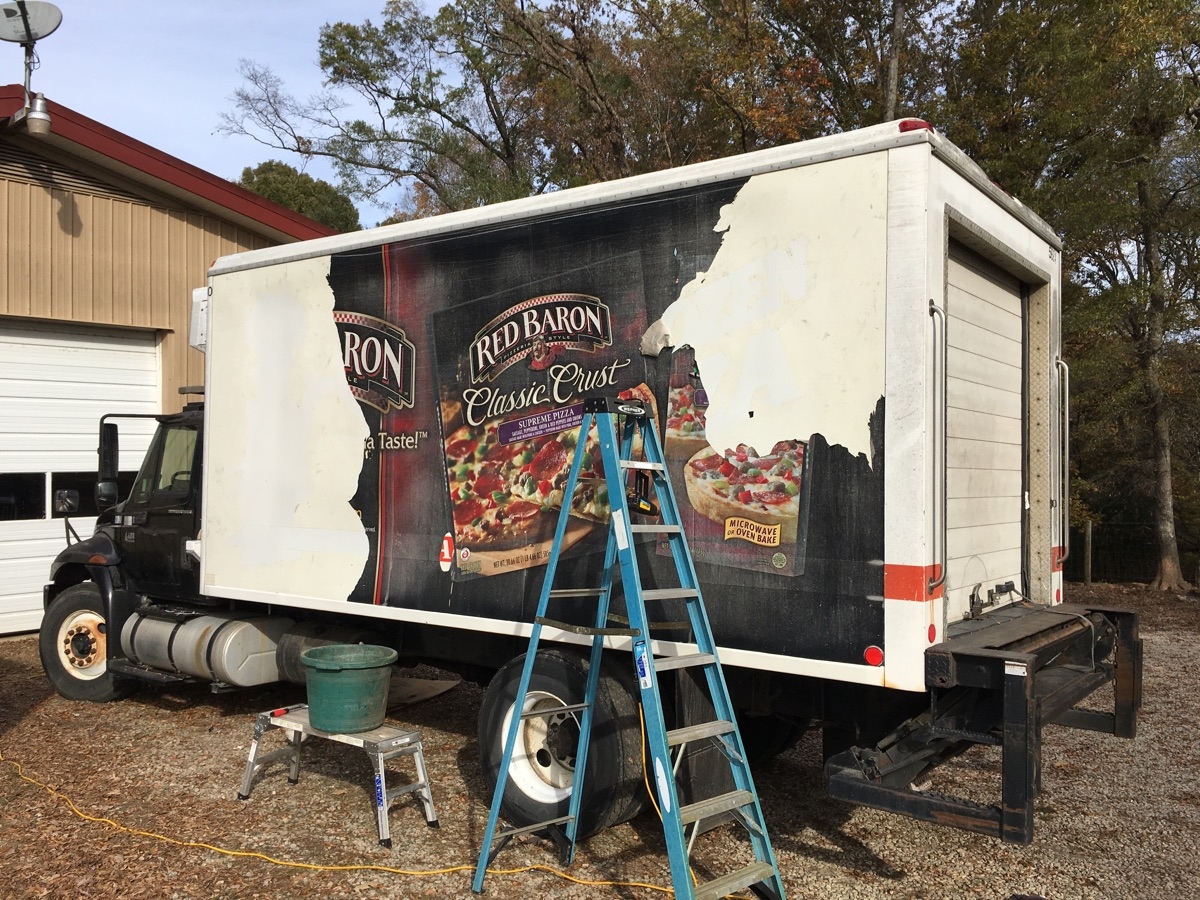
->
[0,163,272,412]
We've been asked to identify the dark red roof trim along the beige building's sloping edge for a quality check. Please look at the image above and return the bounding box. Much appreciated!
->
[0,84,337,240]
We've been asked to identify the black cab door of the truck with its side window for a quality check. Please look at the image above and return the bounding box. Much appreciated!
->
[116,422,200,607]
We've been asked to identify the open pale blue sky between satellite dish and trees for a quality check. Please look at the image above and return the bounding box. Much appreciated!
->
[7,0,388,226]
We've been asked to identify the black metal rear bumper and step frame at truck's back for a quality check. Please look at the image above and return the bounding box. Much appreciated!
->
[826,604,1142,844]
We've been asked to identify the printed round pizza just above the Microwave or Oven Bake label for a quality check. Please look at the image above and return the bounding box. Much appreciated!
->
[683,440,804,545]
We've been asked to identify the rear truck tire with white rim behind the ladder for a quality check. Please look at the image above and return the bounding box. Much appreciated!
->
[479,648,646,839]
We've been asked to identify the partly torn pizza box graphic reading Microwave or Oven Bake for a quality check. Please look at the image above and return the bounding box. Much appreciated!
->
[659,348,810,575]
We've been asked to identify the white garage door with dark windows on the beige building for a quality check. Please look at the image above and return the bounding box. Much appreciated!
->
[0,319,161,634]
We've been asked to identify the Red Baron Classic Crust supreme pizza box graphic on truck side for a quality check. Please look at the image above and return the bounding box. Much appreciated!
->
[432,256,654,578]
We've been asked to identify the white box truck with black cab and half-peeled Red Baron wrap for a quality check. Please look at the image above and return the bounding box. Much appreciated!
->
[41,119,1141,841]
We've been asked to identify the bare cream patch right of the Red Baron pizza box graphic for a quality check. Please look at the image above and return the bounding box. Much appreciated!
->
[649,155,887,456]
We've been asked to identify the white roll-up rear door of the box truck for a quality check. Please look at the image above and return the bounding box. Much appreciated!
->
[946,245,1025,622]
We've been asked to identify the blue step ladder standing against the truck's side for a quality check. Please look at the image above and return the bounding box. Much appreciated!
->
[472,398,784,900]
